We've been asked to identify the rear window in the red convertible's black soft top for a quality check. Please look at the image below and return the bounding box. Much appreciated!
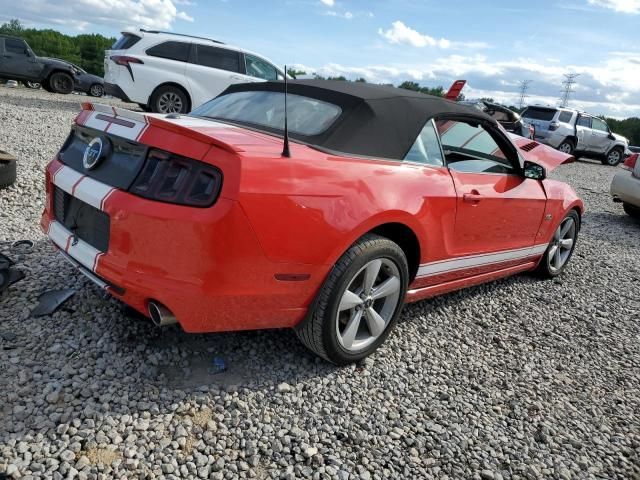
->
[191,91,342,136]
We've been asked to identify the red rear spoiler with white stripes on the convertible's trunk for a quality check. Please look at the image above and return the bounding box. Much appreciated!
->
[76,102,242,153]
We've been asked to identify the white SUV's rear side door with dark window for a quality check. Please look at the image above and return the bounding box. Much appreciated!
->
[186,44,245,108]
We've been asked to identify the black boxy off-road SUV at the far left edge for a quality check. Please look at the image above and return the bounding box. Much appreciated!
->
[0,35,74,93]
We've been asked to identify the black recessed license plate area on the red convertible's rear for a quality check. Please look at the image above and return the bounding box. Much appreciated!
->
[53,186,111,252]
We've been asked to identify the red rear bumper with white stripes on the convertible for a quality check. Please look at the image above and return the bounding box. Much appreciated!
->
[41,160,328,332]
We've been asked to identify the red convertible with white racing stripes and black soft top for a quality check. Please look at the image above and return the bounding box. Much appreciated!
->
[42,80,583,364]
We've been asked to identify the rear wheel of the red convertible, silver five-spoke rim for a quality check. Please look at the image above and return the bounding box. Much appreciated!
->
[296,234,409,365]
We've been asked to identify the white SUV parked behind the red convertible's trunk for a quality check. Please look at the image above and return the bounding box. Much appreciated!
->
[104,29,284,113]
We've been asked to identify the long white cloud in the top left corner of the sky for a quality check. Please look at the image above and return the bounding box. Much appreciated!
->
[0,0,193,30]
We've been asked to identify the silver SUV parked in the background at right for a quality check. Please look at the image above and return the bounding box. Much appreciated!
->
[522,105,631,166]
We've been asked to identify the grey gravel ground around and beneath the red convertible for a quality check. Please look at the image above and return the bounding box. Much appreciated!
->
[0,88,640,480]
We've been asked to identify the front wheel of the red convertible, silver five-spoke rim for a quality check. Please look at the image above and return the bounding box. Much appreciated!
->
[536,210,580,278]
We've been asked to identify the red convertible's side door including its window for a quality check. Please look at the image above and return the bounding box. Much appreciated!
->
[436,118,546,258]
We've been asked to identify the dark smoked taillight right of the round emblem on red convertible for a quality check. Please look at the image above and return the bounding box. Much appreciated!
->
[129,150,222,207]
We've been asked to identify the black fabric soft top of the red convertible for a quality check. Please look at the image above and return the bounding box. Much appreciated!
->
[220,80,496,159]
